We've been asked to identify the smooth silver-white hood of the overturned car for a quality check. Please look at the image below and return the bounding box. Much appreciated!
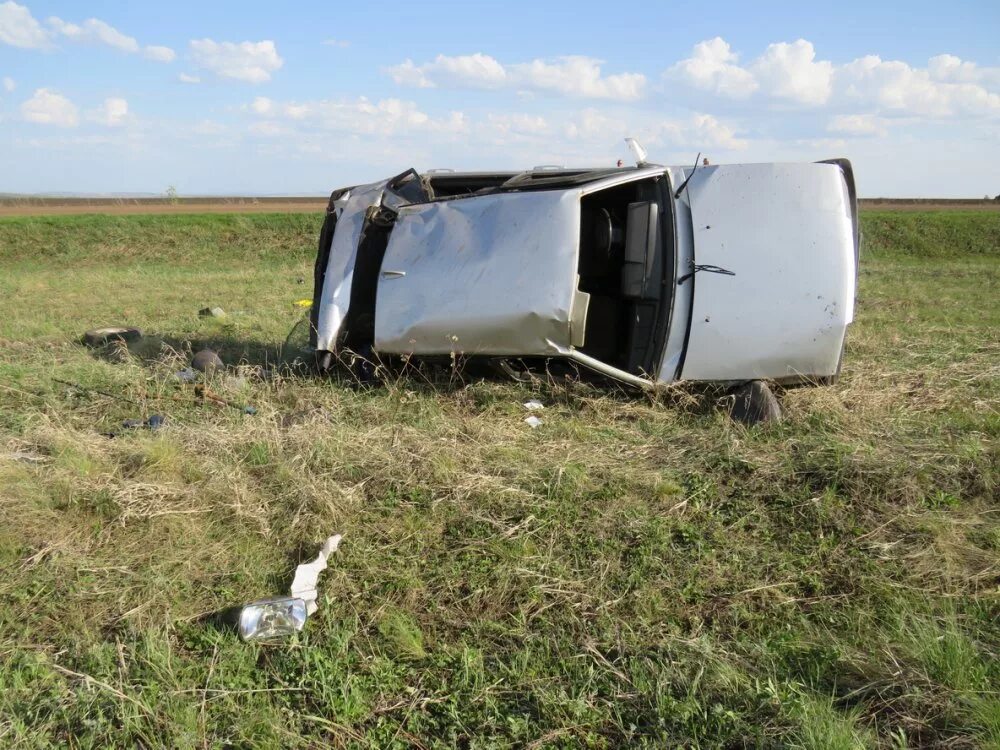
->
[681,164,855,380]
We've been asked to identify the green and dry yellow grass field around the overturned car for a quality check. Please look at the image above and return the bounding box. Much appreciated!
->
[0,211,1000,748]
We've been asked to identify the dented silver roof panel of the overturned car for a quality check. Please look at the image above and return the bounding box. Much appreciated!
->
[375,191,586,356]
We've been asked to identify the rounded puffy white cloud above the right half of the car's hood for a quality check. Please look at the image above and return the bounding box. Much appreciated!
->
[750,39,833,104]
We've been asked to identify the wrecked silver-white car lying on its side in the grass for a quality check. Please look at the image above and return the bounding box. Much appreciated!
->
[311,148,859,394]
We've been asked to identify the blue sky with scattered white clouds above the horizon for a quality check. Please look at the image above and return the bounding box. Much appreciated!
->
[0,0,1000,198]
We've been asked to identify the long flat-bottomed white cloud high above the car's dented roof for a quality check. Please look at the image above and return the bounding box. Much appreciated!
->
[385,52,646,101]
